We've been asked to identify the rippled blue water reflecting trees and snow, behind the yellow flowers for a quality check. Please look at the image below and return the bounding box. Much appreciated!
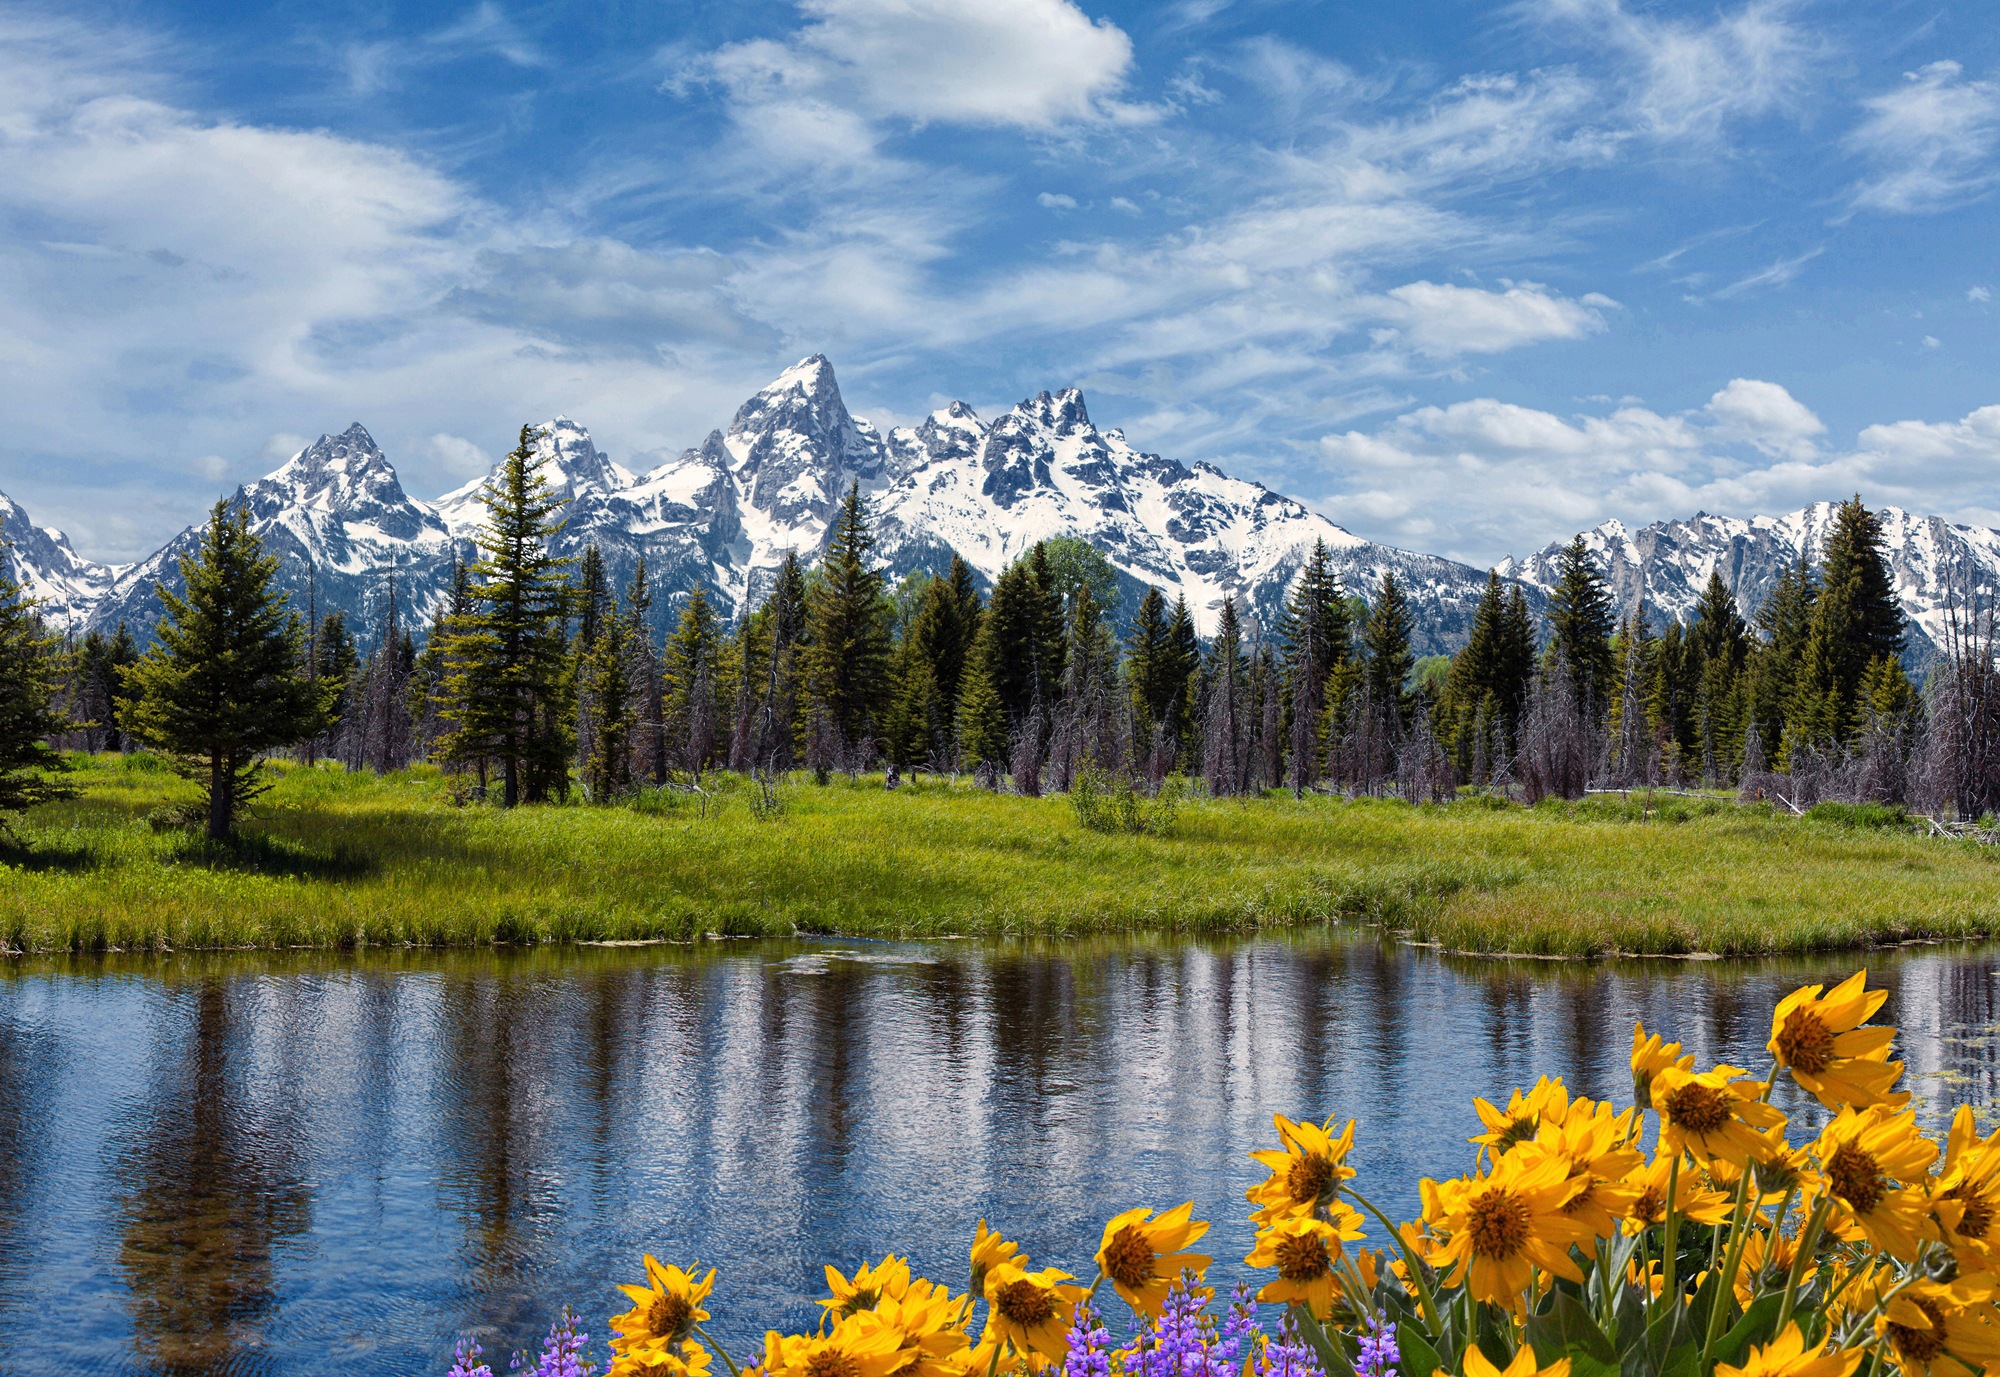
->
[0,937,2000,1377]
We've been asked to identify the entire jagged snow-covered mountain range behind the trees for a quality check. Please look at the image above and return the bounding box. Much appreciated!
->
[11,354,2000,660]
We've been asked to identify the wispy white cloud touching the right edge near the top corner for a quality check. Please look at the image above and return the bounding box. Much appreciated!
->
[1846,62,2000,214]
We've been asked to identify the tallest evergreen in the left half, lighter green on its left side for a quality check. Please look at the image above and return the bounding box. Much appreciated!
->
[440,426,574,809]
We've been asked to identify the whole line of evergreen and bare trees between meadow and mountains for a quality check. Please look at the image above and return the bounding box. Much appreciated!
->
[0,428,2000,837]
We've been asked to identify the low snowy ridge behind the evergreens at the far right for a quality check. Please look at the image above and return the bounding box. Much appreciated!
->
[1500,502,2000,664]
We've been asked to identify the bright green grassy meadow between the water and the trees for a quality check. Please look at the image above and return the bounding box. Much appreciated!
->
[0,757,2000,957]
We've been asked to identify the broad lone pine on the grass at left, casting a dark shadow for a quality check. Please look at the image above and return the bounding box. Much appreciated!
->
[126,502,324,841]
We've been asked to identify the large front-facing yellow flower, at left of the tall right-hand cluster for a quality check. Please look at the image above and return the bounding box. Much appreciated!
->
[1420,1143,1592,1313]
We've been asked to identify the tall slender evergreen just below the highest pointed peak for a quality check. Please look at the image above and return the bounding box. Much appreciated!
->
[806,482,890,763]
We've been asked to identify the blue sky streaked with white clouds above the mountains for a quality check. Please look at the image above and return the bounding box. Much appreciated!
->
[0,0,2000,562]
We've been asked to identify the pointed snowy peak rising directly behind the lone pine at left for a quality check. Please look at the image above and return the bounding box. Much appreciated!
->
[88,422,452,634]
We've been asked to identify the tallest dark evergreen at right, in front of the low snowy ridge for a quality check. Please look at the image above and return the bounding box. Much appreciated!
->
[1786,494,1902,749]
